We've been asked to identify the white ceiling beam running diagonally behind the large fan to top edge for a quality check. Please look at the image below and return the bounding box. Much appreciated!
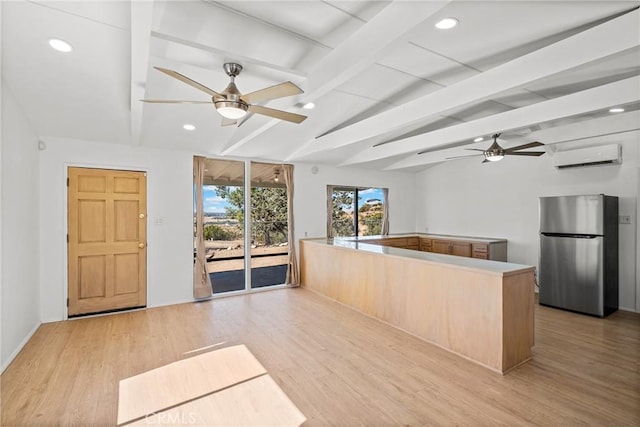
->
[222,0,452,155]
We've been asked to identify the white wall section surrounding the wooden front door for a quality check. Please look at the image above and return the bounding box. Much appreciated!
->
[40,139,193,322]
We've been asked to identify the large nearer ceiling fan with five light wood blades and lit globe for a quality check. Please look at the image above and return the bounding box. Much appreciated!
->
[141,62,307,126]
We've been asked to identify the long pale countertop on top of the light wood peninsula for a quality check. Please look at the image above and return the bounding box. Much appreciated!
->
[300,234,535,275]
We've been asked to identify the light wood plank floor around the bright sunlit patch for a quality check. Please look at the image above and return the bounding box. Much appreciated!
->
[0,289,640,426]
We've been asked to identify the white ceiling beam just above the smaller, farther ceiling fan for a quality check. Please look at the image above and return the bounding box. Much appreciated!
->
[382,76,640,170]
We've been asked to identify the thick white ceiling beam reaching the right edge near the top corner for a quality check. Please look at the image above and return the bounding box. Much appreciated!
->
[288,9,640,160]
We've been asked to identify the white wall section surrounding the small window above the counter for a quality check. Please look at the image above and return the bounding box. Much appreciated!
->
[293,163,415,239]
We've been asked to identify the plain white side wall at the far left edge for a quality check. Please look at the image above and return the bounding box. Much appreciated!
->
[0,82,40,371]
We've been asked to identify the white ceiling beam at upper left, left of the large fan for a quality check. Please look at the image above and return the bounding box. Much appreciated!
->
[129,1,154,145]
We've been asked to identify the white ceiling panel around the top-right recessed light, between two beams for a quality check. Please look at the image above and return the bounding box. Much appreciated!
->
[412,1,634,71]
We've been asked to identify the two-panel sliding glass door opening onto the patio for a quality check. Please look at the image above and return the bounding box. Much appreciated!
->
[194,159,289,294]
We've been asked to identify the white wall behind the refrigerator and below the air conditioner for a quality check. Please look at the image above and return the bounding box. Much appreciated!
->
[416,131,640,311]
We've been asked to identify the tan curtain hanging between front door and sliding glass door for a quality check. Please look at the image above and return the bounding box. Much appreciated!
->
[193,156,213,299]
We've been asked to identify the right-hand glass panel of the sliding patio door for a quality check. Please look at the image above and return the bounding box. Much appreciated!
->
[250,162,289,288]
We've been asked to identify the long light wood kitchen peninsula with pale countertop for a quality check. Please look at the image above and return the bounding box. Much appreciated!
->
[300,238,535,374]
